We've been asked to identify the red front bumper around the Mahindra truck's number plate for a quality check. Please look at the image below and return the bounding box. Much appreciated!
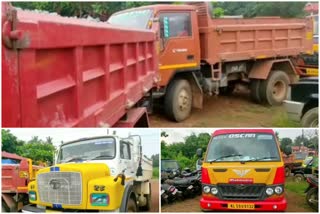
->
[200,197,287,212]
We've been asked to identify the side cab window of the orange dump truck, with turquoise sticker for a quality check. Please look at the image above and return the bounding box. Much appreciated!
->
[160,13,192,39]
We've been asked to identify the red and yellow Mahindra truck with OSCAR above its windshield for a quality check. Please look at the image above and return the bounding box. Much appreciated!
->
[197,129,290,212]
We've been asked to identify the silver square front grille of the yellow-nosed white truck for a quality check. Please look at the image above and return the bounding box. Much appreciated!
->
[37,172,82,205]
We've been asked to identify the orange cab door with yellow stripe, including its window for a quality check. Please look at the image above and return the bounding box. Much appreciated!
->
[159,11,200,84]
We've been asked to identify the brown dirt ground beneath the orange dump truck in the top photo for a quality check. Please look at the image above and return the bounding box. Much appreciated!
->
[149,89,299,127]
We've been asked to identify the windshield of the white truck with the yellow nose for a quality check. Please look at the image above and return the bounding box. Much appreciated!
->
[57,138,116,163]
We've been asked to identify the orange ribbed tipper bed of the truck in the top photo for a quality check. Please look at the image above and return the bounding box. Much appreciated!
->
[190,3,313,64]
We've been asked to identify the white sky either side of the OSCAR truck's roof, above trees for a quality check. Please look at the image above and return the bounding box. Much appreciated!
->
[161,128,316,144]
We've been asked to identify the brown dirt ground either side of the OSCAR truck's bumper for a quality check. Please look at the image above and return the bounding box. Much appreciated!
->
[161,192,314,212]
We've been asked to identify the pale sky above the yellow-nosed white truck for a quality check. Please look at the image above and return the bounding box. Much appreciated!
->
[6,128,160,158]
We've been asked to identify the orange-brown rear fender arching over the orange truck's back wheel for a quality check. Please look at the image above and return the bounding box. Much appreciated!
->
[249,59,297,83]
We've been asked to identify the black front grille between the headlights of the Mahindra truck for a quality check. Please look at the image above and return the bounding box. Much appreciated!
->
[217,184,265,200]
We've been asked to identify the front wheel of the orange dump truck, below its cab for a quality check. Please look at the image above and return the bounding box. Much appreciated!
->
[164,79,192,122]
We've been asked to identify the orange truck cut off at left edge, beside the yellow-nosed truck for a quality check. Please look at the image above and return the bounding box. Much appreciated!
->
[1,152,41,212]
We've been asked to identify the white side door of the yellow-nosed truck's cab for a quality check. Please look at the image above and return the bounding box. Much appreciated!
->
[120,141,135,178]
